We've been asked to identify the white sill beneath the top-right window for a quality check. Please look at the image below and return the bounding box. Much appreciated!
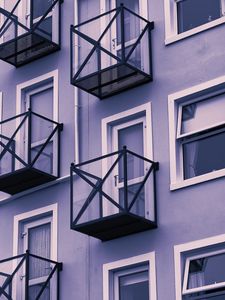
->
[165,16,225,46]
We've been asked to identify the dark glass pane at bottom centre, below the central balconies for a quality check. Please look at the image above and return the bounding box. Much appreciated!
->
[119,271,149,300]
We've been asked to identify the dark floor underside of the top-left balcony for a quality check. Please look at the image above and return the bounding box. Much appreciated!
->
[0,32,60,67]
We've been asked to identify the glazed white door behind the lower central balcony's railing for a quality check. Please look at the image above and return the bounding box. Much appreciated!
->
[112,118,149,217]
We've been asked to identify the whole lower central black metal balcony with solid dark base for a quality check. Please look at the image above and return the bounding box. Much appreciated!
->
[71,147,159,241]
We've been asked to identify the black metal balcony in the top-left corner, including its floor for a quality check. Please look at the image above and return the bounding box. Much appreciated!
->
[0,0,63,67]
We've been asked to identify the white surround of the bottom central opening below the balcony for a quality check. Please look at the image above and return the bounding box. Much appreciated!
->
[103,252,157,300]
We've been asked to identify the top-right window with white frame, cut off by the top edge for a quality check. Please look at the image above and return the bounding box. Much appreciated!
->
[164,0,225,43]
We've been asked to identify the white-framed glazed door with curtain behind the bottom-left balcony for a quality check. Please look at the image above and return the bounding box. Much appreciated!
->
[12,204,57,300]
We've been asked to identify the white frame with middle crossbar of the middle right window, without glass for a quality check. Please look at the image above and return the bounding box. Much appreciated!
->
[168,76,225,190]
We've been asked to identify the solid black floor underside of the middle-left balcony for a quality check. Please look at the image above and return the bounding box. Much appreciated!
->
[0,168,57,195]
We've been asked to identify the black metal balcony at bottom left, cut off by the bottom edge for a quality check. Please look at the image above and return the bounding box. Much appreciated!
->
[0,251,62,300]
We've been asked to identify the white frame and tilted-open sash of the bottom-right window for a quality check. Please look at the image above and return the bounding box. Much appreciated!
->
[174,234,225,300]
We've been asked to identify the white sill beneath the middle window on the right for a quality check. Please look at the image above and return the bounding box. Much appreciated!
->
[170,169,225,191]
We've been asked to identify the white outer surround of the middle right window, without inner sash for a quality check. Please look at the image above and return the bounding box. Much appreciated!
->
[168,76,225,190]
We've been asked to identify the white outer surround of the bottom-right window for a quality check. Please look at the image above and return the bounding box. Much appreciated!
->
[174,234,225,300]
